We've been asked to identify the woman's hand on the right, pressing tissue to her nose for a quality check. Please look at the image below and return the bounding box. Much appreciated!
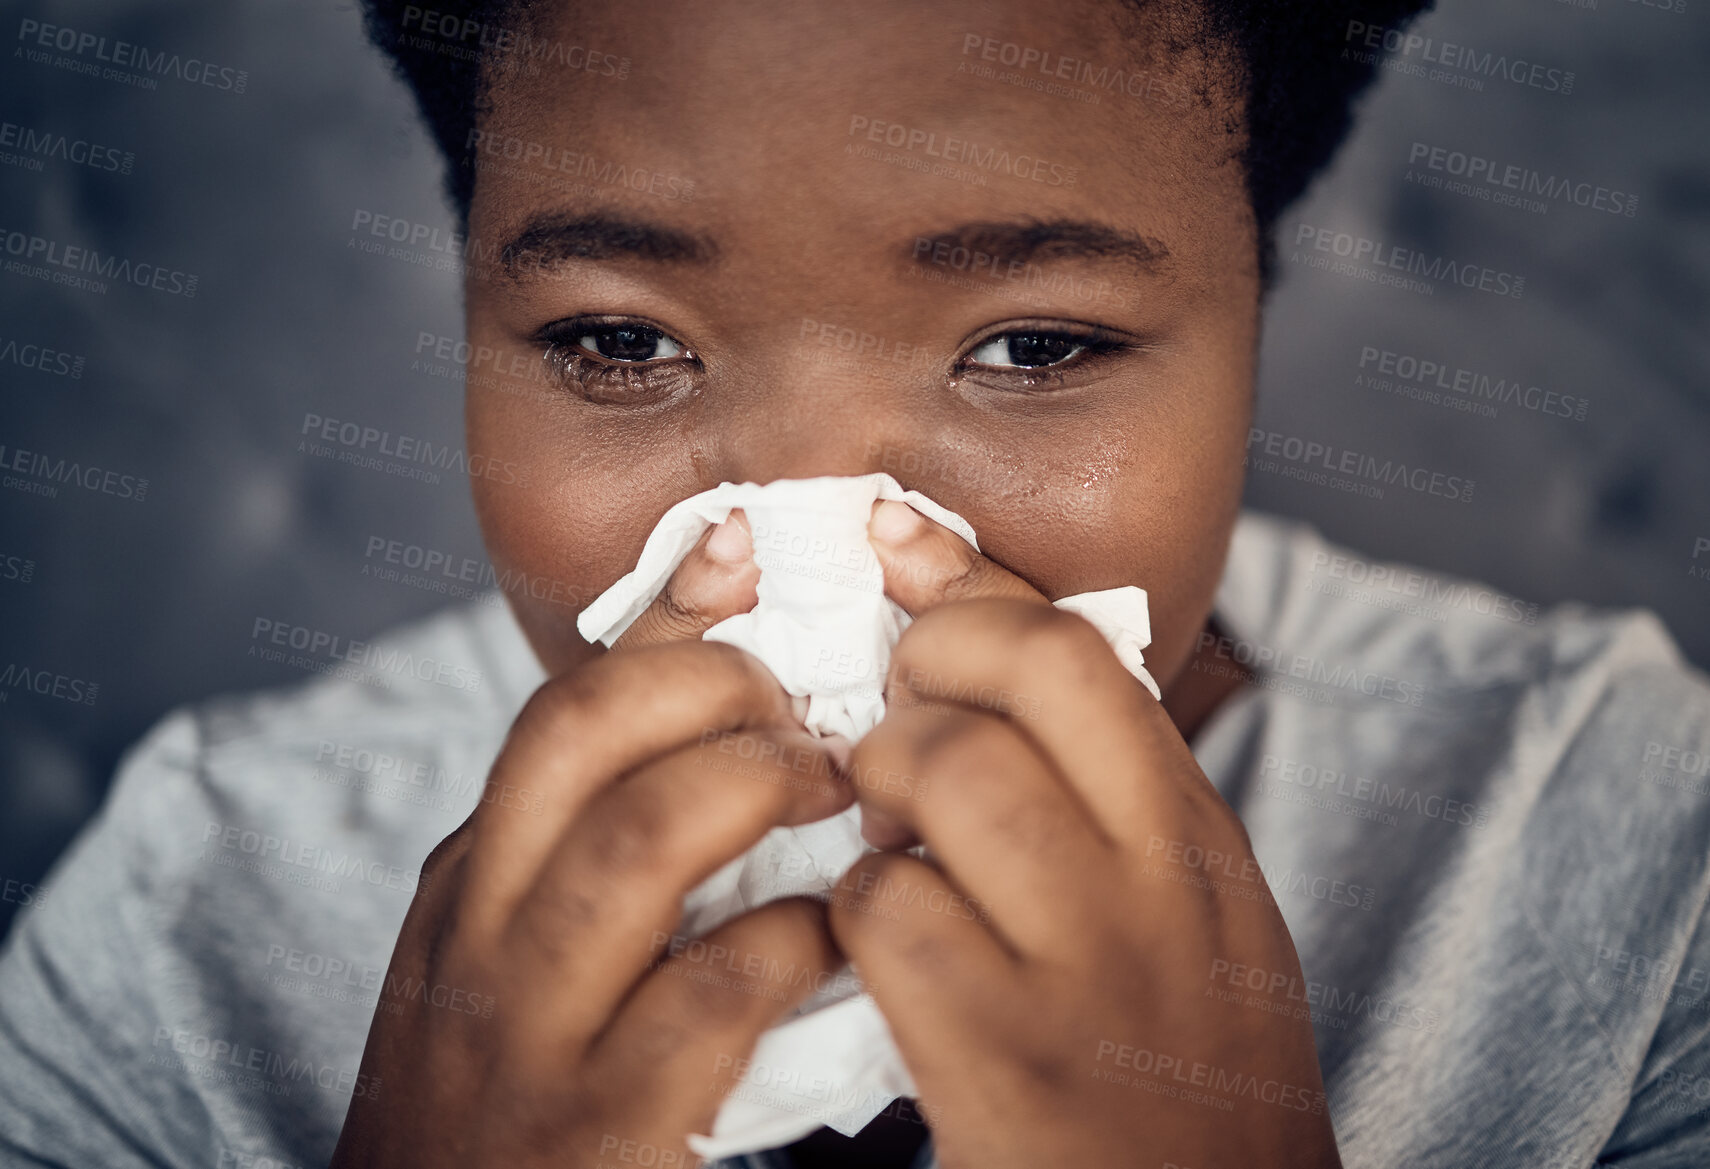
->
[831,504,1341,1169]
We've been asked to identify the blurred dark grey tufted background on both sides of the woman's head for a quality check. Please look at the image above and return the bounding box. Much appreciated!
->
[0,0,1710,928]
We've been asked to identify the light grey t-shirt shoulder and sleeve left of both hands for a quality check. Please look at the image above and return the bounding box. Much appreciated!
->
[0,602,542,1166]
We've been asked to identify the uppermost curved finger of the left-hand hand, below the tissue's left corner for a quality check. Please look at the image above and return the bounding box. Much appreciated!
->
[465,641,795,928]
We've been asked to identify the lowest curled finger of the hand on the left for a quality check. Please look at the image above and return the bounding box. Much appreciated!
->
[590,897,843,1138]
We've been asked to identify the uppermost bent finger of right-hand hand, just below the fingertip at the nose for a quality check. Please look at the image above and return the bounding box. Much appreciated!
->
[886,600,1224,846]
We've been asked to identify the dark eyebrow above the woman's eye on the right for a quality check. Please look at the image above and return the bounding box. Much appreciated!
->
[903,219,1170,275]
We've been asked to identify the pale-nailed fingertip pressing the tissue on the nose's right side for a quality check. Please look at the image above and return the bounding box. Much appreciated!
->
[867,499,1050,617]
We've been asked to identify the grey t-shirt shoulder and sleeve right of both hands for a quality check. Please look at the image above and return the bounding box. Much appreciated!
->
[1195,514,1710,1166]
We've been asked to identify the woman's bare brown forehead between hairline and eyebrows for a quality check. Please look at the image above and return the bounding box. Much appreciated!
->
[472,0,1250,292]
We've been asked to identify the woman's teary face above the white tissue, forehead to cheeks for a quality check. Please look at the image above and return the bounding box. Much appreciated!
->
[465,0,1259,684]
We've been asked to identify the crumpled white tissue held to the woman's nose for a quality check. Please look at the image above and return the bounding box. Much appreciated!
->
[576,473,1159,1160]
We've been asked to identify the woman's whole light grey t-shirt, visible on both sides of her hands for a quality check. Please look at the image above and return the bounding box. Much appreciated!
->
[0,514,1710,1169]
